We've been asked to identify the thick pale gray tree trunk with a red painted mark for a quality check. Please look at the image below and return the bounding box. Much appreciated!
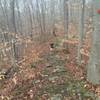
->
[87,0,100,84]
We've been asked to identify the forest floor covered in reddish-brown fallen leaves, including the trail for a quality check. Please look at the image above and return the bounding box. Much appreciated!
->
[0,23,100,100]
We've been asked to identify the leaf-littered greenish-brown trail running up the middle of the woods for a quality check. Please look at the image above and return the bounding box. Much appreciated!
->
[4,47,94,100]
